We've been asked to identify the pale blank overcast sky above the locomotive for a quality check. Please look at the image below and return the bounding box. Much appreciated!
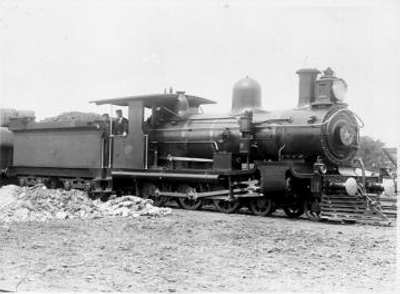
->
[0,0,400,145]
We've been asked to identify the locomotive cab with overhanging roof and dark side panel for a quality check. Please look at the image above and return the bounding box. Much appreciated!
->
[93,92,215,170]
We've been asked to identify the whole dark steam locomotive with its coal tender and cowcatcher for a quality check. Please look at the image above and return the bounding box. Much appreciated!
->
[3,68,394,220]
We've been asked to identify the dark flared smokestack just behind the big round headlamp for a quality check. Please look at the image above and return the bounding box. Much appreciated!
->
[296,68,320,107]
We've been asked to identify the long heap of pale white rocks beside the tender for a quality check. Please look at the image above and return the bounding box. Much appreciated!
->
[0,185,172,223]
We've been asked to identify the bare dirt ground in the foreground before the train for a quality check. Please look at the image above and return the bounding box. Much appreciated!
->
[0,209,399,293]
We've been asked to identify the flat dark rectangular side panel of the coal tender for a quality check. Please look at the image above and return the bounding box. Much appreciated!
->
[14,128,102,168]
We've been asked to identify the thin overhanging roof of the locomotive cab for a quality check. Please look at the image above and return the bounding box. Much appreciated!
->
[90,94,216,108]
